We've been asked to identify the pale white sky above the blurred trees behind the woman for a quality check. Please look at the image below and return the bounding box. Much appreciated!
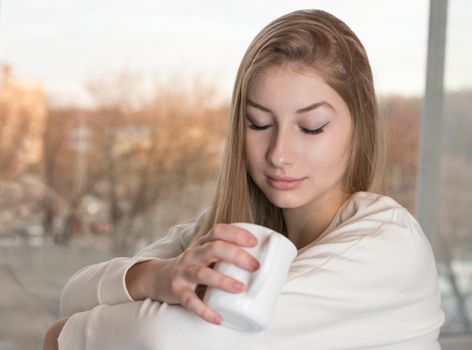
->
[0,0,472,104]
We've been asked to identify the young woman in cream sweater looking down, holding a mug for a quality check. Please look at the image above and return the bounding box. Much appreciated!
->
[45,10,444,350]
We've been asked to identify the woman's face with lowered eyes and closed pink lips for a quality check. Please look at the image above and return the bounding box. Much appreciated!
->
[245,66,351,208]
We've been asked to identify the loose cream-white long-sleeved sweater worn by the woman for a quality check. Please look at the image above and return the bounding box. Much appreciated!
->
[59,192,445,350]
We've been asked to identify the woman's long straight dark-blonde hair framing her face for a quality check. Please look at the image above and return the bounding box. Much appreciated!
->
[192,10,384,242]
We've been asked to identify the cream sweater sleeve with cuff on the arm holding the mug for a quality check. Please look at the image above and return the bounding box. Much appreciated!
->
[60,211,206,316]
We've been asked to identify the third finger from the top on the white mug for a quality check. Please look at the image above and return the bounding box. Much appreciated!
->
[185,265,245,294]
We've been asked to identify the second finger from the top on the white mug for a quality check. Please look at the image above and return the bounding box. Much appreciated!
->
[195,240,259,272]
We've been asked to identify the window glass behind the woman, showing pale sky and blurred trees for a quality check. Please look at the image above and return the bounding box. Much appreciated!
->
[0,0,472,350]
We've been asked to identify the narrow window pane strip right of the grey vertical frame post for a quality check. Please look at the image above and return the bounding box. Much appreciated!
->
[437,0,472,333]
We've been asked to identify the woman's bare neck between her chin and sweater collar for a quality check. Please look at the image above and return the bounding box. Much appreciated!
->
[283,191,349,250]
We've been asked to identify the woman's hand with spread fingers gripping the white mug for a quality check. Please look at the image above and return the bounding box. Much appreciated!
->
[152,224,259,324]
